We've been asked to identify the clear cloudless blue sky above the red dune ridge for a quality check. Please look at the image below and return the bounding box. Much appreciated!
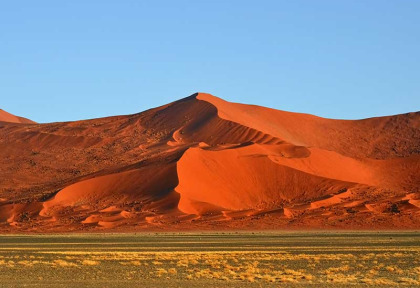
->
[0,0,420,122]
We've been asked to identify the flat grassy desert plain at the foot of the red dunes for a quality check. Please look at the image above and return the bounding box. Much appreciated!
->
[0,232,420,288]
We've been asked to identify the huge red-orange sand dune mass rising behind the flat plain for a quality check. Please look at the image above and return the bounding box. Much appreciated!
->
[0,93,420,233]
